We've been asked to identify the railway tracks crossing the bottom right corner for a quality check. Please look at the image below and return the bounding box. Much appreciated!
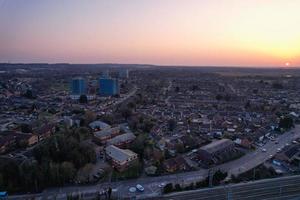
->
[159,175,300,200]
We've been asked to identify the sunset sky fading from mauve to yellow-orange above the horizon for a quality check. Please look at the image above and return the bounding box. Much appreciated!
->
[0,0,300,67]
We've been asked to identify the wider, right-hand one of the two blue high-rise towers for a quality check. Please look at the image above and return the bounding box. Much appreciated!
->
[99,78,120,96]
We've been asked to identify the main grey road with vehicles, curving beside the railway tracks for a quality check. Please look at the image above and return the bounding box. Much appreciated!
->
[9,126,300,199]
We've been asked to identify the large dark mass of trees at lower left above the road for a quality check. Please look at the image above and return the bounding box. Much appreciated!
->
[0,128,96,193]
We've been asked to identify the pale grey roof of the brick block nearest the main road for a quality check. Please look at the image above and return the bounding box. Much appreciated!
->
[105,145,137,162]
